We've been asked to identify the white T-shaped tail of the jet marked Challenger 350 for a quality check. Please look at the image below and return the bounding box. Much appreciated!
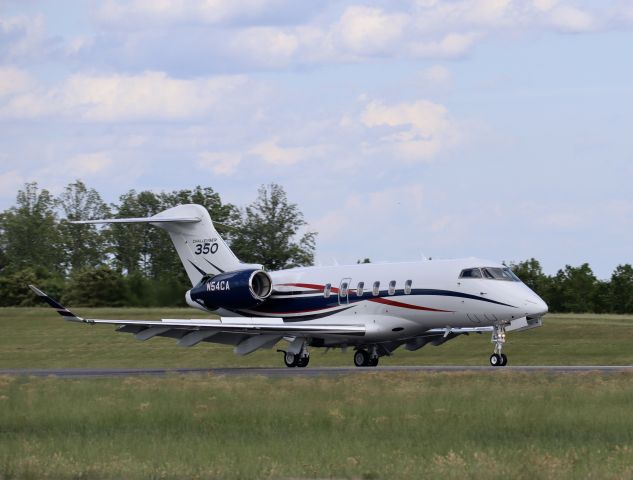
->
[73,204,246,285]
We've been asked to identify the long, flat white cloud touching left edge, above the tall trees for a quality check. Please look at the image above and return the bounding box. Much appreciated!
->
[0,72,246,122]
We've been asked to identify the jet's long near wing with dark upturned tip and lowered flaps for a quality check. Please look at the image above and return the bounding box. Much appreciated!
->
[29,285,365,355]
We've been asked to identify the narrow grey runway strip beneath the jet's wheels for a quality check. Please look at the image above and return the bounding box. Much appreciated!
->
[0,365,633,378]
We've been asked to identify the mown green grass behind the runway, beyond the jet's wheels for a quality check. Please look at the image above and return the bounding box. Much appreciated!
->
[0,308,633,368]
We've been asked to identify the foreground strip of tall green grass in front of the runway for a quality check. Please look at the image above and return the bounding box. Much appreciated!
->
[0,371,633,479]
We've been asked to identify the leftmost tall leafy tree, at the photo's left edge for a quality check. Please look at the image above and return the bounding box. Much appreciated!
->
[0,182,64,272]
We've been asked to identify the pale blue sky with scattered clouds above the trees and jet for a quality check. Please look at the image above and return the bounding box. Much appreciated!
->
[0,0,633,279]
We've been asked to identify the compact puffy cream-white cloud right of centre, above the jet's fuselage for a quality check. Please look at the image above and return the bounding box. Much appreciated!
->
[360,100,456,162]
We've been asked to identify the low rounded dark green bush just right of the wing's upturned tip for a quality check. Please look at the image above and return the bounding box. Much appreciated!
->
[63,265,128,307]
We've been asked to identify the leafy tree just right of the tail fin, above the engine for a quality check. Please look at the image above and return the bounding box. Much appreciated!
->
[231,183,316,270]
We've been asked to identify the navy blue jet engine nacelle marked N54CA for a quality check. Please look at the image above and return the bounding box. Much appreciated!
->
[186,269,273,310]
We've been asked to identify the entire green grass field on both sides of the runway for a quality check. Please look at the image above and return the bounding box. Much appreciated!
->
[0,309,633,480]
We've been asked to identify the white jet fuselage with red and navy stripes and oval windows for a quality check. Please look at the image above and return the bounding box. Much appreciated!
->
[217,258,547,344]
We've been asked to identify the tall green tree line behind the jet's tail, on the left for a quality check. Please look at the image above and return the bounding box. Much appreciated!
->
[0,180,316,306]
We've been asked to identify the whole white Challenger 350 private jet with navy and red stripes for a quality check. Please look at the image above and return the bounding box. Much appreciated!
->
[30,204,548,368]
